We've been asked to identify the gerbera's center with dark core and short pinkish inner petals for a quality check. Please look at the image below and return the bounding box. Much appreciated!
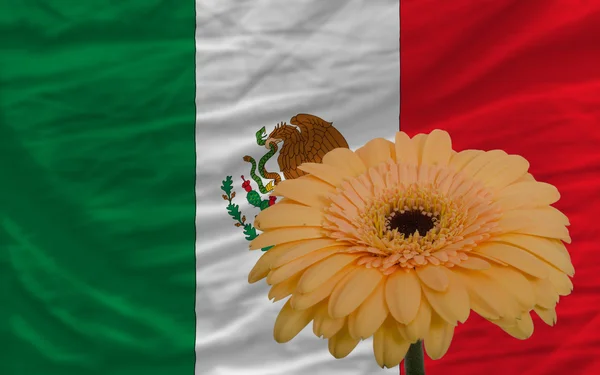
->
[323,162,502,274]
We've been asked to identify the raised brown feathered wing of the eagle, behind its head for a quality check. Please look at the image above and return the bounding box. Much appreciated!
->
[290,114,349,165]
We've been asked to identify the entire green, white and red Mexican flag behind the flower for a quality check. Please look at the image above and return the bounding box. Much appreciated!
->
[0,0,600,375]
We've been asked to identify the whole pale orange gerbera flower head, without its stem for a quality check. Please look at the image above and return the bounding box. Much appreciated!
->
[249,130,574,367]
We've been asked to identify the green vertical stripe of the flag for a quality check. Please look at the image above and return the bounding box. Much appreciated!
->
[0,0,195,375]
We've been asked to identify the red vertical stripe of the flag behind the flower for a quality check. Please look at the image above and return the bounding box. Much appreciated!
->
[400,0,600,375]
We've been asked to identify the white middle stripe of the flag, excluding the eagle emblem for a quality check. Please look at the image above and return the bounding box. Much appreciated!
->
[196,0,399,375]
